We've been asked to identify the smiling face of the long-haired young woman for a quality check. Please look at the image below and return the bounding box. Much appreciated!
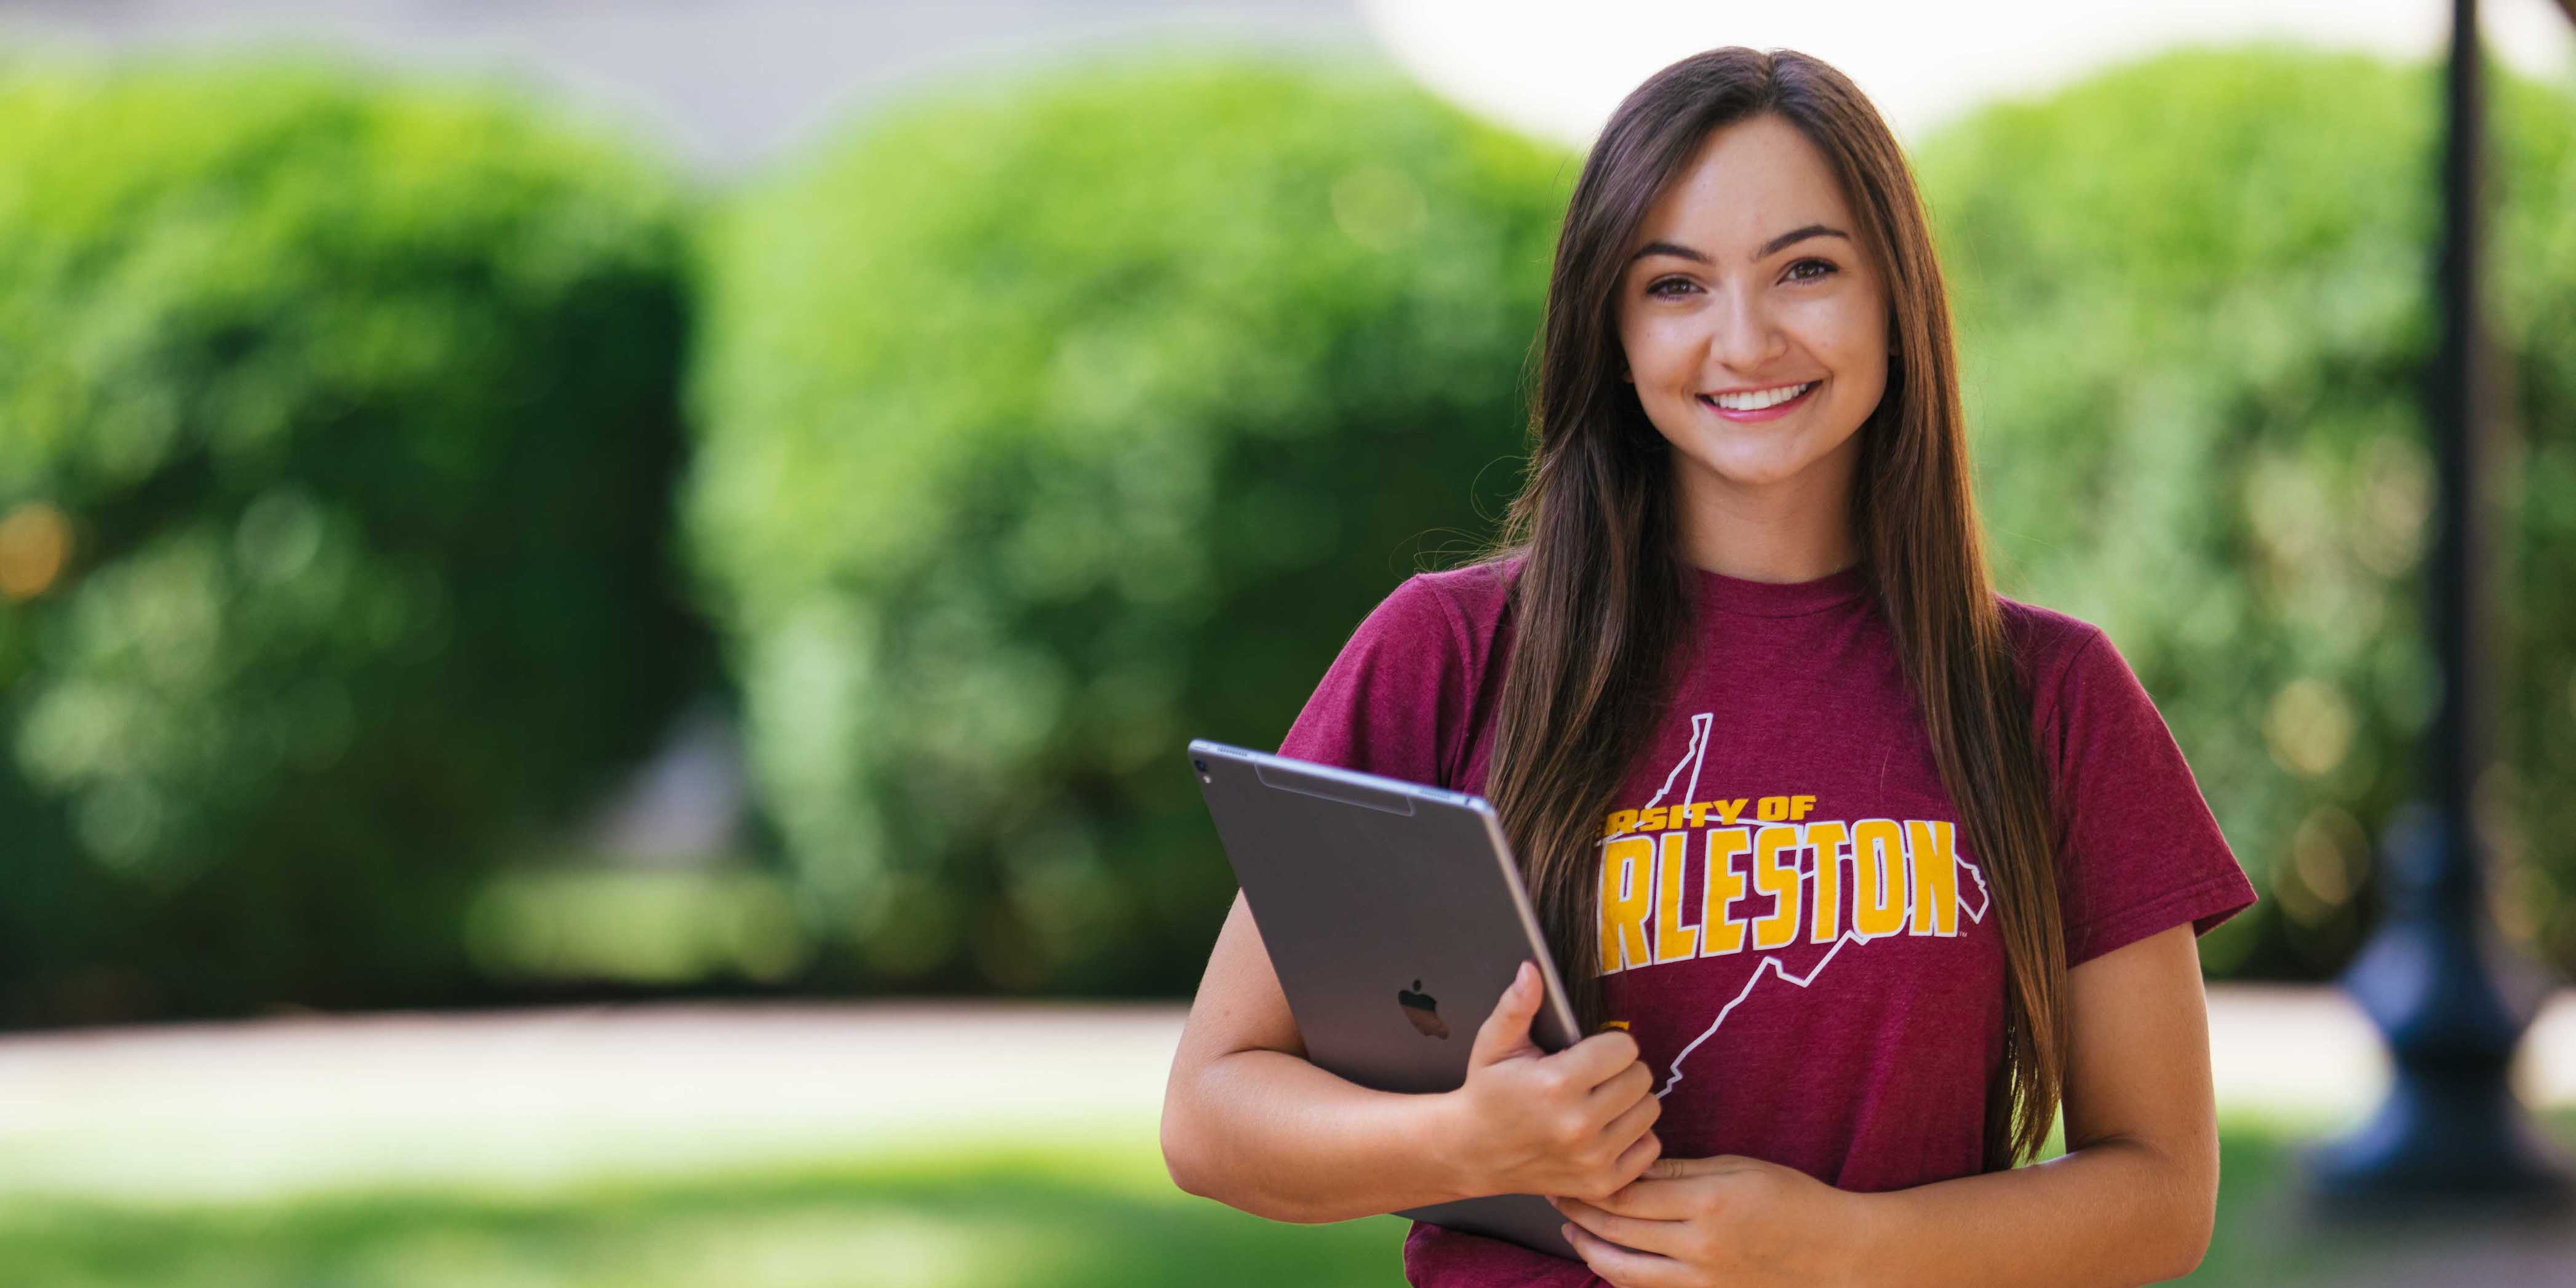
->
[1617,116,1893,492]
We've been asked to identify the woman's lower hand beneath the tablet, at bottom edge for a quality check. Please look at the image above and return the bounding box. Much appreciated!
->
[1548,1154,1865,1288]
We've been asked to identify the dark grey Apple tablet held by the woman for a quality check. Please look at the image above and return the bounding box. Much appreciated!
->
[1190,739,1582,1260]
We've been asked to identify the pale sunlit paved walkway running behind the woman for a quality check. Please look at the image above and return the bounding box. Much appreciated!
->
[0,984,2576,1198]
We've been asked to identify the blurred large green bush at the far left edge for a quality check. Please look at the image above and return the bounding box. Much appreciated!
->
[0,65,711,1023]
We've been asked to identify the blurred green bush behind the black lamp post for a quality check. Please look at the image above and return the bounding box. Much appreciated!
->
[1916,46,2576,974]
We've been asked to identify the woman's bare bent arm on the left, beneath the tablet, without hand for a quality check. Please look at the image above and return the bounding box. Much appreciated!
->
[1162,891,1473,1221]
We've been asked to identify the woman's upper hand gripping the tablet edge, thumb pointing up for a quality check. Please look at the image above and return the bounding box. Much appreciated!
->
[1443,961,1664,1201]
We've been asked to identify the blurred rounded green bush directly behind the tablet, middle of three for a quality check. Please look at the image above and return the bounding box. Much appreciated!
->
[683,54,1574,992]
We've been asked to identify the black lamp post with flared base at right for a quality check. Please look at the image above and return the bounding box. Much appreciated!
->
[2308,0,2568,1210]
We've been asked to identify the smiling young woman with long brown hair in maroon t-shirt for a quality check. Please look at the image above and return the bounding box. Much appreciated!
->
[1165,49,2254,1288]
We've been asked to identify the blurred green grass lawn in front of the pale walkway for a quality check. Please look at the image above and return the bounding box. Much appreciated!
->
[0,1116,2576,1288]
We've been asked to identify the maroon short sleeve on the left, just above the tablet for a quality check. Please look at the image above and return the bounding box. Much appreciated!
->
[1278,572,1471,788]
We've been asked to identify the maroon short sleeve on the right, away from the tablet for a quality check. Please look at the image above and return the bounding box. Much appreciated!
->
[2045,628,2254,966]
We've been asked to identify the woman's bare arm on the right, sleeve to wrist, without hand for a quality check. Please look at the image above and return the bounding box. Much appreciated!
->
[1852,925,2218,1288]
